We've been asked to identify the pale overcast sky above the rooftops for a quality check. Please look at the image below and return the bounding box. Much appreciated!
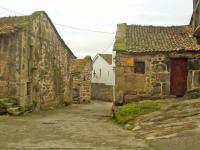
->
[0,0,193,58]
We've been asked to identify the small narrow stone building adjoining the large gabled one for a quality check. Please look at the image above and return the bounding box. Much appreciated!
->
[71,56,92,103]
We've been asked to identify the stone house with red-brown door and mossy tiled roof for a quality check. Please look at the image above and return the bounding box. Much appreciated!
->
[114,24,200,104]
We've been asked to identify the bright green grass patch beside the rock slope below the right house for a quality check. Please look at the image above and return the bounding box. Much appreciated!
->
[112,101,161,125]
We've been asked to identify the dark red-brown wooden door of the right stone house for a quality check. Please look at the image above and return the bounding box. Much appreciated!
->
[170,58,188,97]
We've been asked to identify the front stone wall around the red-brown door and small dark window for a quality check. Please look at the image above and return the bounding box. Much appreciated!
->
[115,52,200,103]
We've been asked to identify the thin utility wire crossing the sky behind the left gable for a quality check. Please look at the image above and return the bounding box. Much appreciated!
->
[0,6,115,35]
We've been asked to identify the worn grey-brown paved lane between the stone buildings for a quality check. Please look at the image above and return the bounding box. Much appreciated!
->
[0,102,150,150]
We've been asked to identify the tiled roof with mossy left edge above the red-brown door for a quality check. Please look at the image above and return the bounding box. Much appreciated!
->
[114,24,200,52]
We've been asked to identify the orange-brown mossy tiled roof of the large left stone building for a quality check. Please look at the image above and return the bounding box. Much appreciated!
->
[0,16,30,34]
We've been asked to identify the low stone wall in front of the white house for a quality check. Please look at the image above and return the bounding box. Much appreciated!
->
[92,83,113,102]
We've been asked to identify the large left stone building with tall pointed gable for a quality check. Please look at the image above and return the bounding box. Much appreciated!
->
[0,11,76,113]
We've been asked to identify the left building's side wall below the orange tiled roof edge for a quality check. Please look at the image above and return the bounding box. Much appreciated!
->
[0,34,21,98]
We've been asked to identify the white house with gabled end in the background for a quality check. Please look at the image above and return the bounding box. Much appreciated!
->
[92,54,115,85]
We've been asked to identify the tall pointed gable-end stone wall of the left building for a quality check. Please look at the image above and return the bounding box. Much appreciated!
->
[24,13,73,110]
